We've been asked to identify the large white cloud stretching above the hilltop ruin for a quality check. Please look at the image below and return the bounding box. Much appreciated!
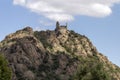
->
[13,0,120,21]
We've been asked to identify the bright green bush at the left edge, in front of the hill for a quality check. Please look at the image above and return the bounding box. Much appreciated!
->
[0,54,12,80]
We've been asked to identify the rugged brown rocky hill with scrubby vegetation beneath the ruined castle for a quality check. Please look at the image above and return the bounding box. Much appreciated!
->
[0,27,120,80]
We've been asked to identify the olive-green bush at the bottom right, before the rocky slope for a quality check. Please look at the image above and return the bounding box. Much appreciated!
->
[70,57,111,80]
